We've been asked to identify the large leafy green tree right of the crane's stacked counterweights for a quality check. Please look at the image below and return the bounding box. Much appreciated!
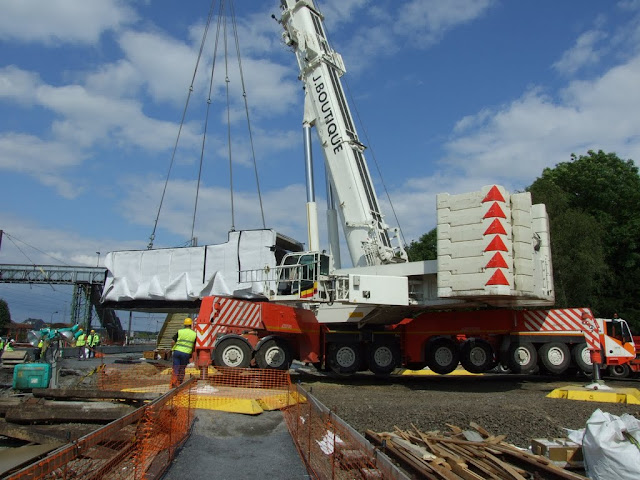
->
[528,150,640,332]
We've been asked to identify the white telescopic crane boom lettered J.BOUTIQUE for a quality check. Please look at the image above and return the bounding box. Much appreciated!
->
[281,0,407,267]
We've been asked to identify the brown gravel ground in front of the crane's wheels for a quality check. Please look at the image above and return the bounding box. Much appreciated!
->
[296,374,640,448]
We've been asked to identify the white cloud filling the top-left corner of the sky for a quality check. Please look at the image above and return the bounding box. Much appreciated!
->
[0,0,136,44]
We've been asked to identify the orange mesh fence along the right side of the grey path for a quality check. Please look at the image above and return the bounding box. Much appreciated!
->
[283,386,409,480]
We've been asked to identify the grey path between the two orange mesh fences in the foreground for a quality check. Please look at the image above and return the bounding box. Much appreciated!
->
[162,410,311,480]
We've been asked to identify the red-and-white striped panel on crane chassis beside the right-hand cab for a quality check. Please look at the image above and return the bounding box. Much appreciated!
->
[523,308,600,349]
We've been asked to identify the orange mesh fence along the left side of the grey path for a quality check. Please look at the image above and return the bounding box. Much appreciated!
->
[8,380,195,480]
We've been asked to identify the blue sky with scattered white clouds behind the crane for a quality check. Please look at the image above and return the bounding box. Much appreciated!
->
[0,0,640,329]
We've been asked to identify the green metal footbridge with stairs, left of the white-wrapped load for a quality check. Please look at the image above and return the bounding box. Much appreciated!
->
[0,264,125,342]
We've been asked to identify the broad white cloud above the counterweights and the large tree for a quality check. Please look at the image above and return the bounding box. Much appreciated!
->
[383,51,640,241]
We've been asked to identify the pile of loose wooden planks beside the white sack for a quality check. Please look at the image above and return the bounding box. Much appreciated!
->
[365,423,586,480]
